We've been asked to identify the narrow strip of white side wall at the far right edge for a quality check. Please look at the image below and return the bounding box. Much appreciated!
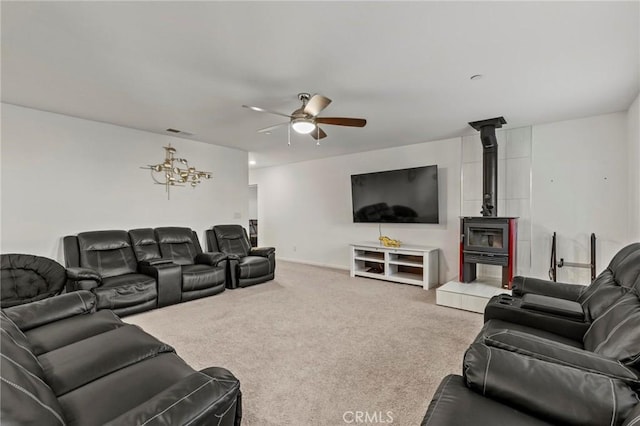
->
[627,94,640,241]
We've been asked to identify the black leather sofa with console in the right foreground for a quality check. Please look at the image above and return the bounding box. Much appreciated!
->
[422,243,640,426]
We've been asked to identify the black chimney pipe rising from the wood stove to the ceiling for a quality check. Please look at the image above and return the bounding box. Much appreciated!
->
[469,117,507,216]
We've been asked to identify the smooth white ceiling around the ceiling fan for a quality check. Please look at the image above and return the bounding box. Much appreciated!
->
[1,1,640,167]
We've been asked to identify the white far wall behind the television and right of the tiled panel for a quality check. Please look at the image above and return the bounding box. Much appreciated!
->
[249,112,637,283]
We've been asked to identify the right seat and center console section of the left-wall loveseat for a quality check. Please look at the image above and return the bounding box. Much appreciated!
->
[129,227,227,307]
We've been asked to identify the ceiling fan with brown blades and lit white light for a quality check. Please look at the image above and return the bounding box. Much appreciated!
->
[242,93,367,140]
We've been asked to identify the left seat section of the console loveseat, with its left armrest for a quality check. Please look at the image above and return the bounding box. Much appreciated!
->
[63,231,158,316]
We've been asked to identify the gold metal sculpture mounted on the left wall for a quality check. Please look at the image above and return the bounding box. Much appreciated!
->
[141,144,211,199]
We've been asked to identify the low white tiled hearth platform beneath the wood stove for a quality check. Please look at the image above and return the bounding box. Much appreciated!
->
[436,277,511,313]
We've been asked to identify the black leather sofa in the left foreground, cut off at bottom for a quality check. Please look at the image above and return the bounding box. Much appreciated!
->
[0,290,241,426]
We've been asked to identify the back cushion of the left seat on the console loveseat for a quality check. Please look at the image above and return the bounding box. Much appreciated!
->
[78,231,138,278]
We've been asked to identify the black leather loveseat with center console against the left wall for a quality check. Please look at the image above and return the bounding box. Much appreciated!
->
[63,227,227,316]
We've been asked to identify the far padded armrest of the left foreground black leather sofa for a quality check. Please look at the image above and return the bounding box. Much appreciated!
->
[2,290,96,331]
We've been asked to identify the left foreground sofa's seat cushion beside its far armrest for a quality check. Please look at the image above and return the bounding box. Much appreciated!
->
[25,310,124,355]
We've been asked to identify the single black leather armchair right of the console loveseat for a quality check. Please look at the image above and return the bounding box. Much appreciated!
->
[206,225,276,288]
